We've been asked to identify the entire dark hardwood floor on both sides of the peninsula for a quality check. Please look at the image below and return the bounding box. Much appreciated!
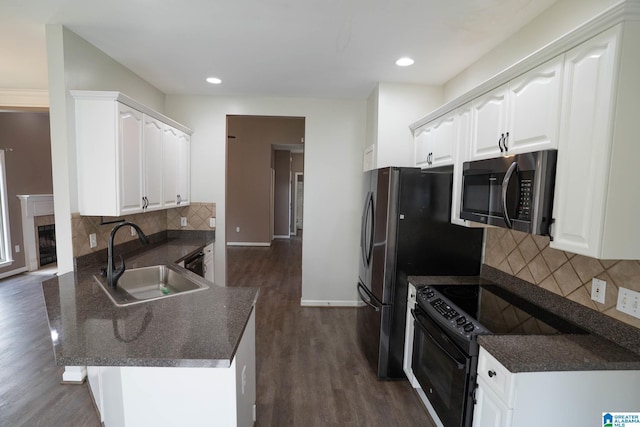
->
[0,238,434,427]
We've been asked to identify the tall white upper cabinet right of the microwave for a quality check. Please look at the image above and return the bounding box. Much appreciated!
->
[551,22,640,259]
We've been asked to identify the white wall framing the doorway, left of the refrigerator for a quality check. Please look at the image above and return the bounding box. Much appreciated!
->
[166,95,366,304]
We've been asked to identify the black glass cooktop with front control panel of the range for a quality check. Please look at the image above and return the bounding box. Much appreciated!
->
[416,284,586,354]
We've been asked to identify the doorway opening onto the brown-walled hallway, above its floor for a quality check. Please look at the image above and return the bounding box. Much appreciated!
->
[225,115,305,246]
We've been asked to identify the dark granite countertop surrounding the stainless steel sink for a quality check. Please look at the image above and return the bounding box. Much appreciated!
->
[42,233,258,367]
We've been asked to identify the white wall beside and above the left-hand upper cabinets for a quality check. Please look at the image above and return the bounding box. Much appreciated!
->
[46,25,164,274]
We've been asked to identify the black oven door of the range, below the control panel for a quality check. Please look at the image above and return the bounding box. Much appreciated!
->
[411,306,473,427]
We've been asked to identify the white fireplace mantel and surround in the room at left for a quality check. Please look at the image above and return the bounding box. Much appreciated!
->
[17,194,53,271]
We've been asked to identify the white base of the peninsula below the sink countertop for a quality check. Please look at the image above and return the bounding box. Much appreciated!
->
[87,310,256,427]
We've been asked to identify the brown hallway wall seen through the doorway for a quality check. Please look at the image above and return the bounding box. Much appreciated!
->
[226,116,305,244]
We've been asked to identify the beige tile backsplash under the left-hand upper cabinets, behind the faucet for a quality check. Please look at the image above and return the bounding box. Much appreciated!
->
[71,203,216,257]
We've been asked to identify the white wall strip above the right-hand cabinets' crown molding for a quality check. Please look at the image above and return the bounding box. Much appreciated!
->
[444,0,619,102]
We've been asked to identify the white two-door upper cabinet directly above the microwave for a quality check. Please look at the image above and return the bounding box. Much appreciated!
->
[471,56,563,160]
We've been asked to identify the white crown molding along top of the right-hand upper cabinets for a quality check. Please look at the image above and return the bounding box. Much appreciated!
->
[409,0,640,132]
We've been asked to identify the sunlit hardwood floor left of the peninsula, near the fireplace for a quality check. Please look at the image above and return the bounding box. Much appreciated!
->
[0,273,100,427]
